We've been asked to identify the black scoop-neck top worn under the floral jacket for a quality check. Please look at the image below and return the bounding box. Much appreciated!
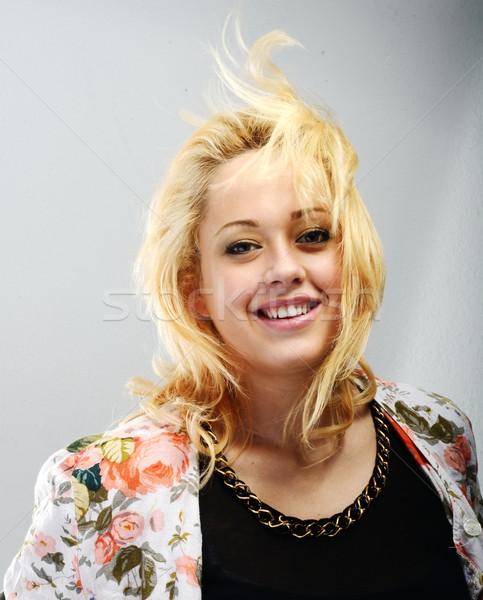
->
[200,412,470,600]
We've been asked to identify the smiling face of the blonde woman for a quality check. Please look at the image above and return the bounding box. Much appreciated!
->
[197,152,341,375]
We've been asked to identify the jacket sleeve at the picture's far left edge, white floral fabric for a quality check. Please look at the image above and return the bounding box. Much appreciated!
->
[4,450,88,600]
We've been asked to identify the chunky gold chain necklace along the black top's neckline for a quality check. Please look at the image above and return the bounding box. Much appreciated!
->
[205,401,390,538]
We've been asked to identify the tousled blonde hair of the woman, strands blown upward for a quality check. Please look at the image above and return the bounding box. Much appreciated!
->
[129,31,384,476]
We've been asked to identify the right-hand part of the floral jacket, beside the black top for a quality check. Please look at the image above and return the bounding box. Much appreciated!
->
[376,381,483,599]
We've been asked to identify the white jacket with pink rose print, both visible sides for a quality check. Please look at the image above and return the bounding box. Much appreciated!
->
[4,381,483,600]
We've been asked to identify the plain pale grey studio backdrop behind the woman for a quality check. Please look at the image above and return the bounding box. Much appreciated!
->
[0,0,483,576]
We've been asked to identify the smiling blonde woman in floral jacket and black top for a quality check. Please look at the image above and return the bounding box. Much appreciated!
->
[5,32,483,600]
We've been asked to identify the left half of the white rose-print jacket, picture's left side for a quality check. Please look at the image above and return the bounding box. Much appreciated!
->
[5,417,201,600]
